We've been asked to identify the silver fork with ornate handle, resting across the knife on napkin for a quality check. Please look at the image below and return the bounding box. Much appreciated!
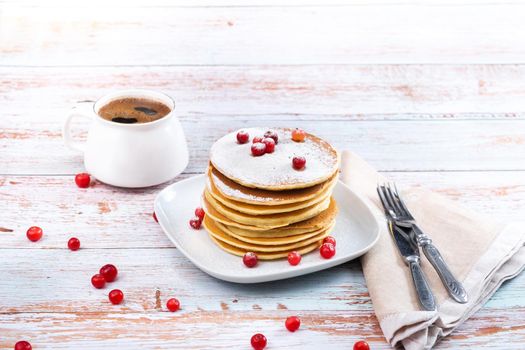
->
[379,183,468,304]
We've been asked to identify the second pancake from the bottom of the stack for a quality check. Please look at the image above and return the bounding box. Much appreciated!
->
[203,217,330,253]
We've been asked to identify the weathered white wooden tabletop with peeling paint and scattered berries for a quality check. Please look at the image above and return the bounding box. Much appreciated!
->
[0,0,525,349]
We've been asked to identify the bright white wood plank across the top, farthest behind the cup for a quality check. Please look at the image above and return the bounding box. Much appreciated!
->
[0,3,525,65]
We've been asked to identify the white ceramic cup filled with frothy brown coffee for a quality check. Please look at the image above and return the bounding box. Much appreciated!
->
[62,90,189,187]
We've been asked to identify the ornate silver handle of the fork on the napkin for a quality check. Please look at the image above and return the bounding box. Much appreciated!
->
[413,225,468,304]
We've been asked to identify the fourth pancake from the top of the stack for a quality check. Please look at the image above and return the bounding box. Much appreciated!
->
[204,189,330,229]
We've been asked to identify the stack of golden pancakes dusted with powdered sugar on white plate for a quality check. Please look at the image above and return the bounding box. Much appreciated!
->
[203,128,339,260]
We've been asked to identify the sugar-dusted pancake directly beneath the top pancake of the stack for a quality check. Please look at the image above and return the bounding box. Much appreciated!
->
[207,164,338,205]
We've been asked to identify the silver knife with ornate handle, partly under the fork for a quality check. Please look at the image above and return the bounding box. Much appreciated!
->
[388,219,436,311]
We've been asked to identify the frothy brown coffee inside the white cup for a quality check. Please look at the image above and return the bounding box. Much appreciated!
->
[98,97,171,124]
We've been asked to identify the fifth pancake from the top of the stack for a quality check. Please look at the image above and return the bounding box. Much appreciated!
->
[203,198,337,237]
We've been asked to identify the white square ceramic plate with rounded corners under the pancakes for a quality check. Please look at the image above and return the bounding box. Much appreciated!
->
[155,175,379,283]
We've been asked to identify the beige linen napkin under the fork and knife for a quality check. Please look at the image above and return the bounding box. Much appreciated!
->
[341,151,525,350]
